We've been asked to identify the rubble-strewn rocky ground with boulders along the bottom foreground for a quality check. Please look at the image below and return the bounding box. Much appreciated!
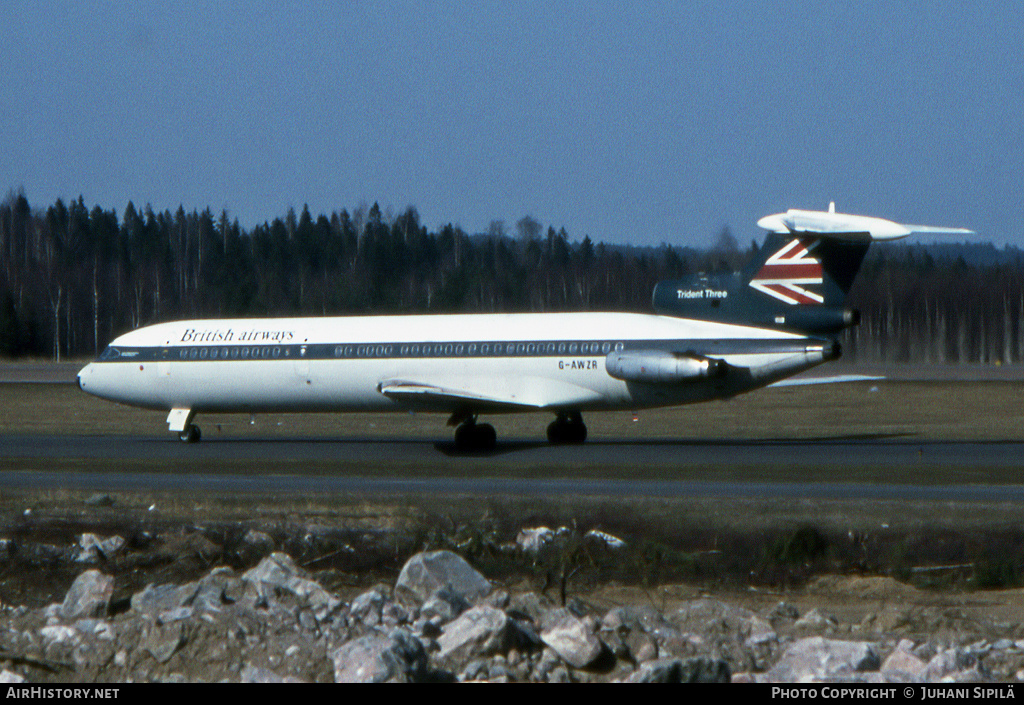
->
[0,518,1024,682]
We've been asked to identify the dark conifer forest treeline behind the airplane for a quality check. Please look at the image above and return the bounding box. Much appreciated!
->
[0,192,1024,364]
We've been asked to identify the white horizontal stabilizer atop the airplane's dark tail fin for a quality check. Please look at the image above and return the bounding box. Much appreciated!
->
[758,209,974,242]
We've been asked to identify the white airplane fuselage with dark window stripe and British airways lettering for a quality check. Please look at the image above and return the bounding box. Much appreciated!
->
[79,313,835,422]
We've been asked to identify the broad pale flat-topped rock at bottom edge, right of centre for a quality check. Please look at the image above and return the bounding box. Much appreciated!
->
[768,636,881,682]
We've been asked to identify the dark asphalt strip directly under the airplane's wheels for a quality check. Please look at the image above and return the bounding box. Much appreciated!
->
[0,434,1024,469]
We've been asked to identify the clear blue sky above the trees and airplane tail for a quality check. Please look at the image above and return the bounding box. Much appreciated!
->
[0,0,1024,246]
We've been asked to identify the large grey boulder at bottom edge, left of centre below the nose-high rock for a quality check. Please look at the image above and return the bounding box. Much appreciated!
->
[331,629,428,682]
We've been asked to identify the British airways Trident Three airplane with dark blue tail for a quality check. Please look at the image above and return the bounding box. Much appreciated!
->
[78,203,972,451]
